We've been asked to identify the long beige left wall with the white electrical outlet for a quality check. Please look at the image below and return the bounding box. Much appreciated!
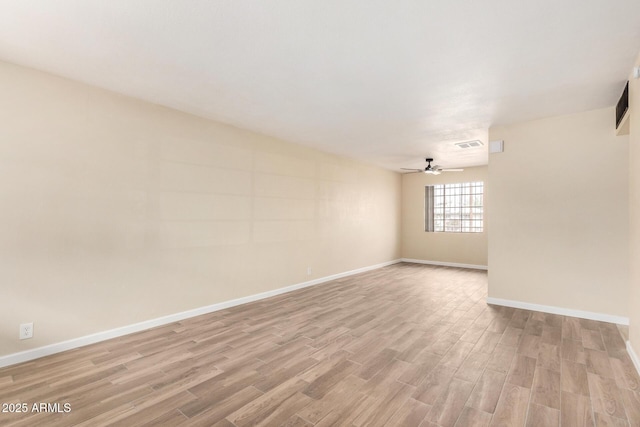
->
[0,63,401,355]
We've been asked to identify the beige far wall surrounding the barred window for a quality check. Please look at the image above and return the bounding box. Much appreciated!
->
[402,166,489,266]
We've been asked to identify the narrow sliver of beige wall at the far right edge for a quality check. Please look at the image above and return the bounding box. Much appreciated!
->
[629,55,640,356]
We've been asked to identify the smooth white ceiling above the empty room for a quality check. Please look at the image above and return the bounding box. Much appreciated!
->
[0,0,640,170]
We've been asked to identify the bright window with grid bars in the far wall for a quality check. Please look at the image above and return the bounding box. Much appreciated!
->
[424,182,484,233]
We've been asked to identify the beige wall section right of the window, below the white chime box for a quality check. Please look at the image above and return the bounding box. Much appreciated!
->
[489,108,629,316]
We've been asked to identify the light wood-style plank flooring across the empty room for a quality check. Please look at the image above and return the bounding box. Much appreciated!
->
[0,263,640,427]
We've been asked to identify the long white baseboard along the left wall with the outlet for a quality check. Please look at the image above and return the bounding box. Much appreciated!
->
[0,259,402,368]
